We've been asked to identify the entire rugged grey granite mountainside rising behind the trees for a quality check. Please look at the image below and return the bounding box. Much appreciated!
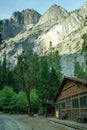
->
[0,2,87,75]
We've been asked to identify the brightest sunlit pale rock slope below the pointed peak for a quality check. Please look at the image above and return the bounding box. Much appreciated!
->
[35,13,84,53]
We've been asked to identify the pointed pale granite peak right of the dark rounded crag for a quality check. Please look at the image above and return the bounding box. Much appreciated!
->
[38,4,69,26]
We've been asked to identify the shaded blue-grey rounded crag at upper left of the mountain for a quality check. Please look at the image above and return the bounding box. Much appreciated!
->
[3,9,41,40]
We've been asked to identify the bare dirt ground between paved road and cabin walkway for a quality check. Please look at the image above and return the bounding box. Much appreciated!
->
[10,114,67,130]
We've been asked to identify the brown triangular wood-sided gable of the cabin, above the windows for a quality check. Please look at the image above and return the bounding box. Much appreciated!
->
[57,80,87,102]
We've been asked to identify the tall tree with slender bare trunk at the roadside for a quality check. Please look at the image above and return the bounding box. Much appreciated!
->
[15,50,39,115]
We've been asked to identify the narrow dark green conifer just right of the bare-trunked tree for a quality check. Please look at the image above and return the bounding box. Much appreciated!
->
[36,57,49,103]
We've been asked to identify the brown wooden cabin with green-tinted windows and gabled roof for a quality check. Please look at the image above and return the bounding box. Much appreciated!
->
[54,77,87,120]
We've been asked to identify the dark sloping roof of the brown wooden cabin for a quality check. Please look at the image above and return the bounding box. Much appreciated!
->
[53,76,87,102]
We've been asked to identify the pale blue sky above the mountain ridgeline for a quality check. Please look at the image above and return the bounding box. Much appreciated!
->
[0,0,87,19]
